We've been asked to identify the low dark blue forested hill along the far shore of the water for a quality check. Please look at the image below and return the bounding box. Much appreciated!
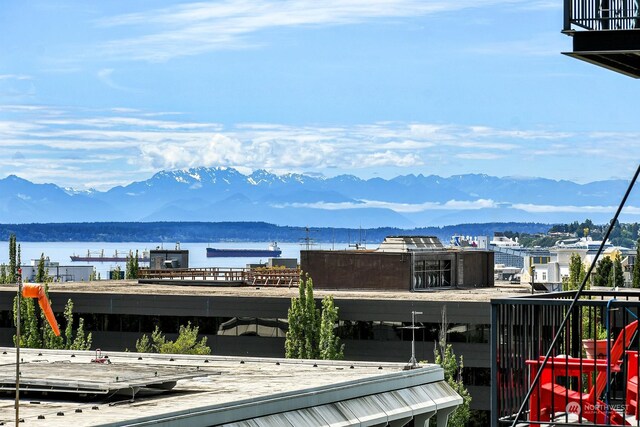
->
[0,222,550,242]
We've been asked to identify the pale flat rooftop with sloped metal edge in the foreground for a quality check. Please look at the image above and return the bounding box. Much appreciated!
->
[0,347,461,427]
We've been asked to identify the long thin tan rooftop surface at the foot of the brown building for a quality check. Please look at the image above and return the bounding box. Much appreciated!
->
[5,280,531,302]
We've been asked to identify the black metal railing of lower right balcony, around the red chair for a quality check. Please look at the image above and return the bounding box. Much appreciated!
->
[491,291,640,426]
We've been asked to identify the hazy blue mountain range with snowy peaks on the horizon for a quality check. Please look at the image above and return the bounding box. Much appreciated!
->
[0,168,638,228]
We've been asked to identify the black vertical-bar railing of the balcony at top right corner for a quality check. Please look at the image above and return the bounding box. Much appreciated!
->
[564,0,640,31]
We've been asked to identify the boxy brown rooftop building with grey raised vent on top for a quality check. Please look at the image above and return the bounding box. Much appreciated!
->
[300,236,494,291]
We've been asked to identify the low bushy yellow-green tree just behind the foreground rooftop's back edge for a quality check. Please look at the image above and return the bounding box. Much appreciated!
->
[136,322,211,355]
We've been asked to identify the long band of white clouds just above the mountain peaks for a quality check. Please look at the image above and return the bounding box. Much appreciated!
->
[0,105,640,189]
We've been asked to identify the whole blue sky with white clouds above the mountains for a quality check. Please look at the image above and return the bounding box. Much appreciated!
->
[0,0,640,189]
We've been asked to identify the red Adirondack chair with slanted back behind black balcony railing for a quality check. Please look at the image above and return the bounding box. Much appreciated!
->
[526,320,638,425]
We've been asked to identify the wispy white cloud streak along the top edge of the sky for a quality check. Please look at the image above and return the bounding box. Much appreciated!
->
[98,0,526,61]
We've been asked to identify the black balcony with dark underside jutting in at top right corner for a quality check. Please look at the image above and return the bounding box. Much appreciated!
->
[563,0,640,78]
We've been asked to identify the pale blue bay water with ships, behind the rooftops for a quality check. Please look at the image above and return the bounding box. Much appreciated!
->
[0,242,348,278]
